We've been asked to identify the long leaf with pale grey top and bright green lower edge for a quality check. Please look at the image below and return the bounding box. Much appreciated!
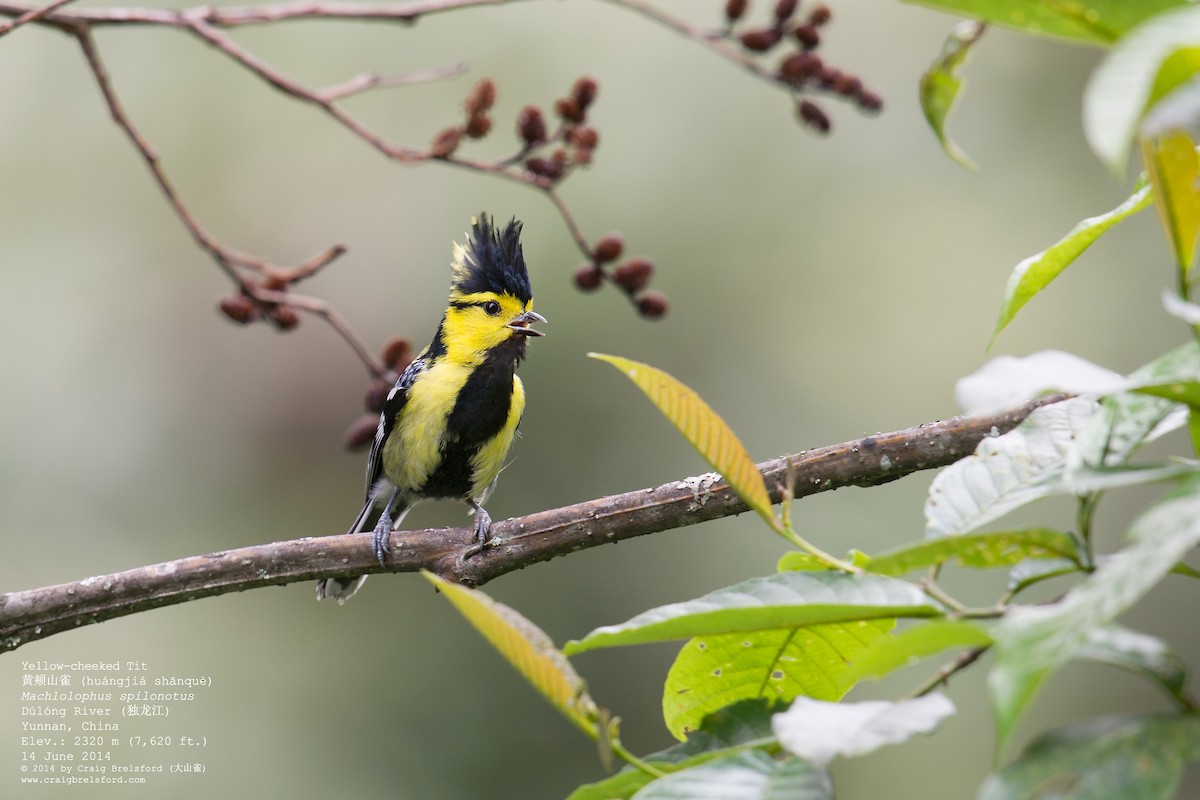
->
[563,572,942,655]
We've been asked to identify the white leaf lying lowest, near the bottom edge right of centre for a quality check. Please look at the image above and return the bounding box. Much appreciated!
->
[772,693,954,765]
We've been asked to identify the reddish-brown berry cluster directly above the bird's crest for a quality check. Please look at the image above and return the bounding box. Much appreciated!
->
[430,77,600,186]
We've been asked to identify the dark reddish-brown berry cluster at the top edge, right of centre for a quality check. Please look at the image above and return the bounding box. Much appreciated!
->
[722,0,883,133]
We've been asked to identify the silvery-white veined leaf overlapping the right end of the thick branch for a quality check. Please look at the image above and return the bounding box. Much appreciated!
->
[925,397,1098,537]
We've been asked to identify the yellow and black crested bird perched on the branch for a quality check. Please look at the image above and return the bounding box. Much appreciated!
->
[317,213,546,603]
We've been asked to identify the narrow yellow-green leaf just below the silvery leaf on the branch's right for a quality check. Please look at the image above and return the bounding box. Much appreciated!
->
[863,528,1079,576]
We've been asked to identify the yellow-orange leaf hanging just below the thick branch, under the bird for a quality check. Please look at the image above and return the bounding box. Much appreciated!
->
[421,570,599,739]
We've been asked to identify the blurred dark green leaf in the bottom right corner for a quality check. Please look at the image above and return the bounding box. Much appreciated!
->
[978,714,1200,800]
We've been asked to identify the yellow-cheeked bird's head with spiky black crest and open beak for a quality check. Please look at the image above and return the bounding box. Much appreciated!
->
[443,213,546,357]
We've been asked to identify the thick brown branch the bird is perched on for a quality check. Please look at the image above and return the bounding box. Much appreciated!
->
[0,396,1062,651]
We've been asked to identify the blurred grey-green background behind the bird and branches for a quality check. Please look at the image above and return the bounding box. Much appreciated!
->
[0,0,1200,800]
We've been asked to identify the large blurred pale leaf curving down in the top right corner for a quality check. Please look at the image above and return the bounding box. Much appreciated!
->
[1084,2,1200,174]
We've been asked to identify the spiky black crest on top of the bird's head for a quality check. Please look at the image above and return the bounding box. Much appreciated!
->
[450,213,533,302]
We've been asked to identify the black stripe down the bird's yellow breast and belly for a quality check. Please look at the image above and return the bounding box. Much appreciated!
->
[420,339,524,498]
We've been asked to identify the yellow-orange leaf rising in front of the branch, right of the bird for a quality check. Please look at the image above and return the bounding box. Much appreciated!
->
[588,353,778,528]
